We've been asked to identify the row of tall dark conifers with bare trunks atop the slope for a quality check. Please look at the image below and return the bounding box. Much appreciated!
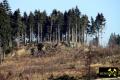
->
[0,0,106,51]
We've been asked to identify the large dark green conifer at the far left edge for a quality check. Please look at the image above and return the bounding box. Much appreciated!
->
[0,3,11,59]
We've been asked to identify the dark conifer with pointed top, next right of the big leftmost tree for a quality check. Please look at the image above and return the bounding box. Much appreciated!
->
[12,9,25,47]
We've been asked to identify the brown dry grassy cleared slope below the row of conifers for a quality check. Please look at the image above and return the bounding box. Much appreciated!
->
[0,43,120,80]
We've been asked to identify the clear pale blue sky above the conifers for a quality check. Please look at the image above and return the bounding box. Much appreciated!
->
[0,0,120,45]
